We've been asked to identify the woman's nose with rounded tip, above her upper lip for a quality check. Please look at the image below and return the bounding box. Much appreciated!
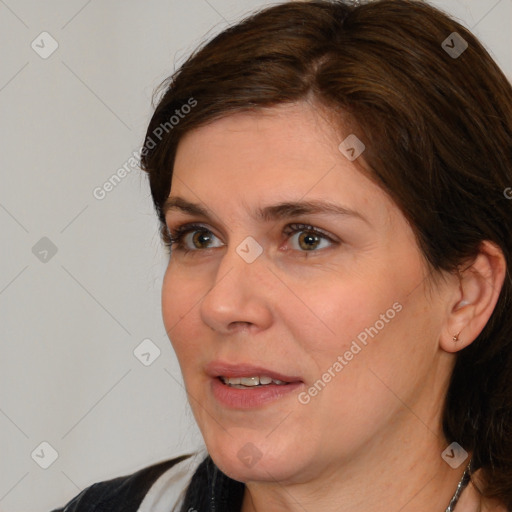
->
[200,244,275,334]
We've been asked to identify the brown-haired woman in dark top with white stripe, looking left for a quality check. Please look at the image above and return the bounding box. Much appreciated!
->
[49,0,512,512]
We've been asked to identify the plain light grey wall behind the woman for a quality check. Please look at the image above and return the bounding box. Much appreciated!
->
[0,0,512,512]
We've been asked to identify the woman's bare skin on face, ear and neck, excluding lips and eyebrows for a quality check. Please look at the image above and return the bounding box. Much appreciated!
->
[162,103,505,512]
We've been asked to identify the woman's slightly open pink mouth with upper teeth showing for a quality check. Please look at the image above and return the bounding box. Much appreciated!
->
[206,362,304,409]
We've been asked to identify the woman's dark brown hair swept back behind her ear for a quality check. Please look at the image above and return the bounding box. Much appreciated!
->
[141,0,512,509]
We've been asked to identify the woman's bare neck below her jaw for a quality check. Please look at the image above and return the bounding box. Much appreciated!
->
[242,424,478,512]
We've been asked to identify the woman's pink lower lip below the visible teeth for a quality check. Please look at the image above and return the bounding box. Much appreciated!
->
[211,378,303,409]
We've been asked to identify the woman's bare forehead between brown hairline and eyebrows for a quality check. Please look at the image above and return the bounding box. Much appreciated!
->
[171,103,394,224]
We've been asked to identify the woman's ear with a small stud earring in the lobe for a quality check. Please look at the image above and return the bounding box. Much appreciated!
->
[440,240,507,352]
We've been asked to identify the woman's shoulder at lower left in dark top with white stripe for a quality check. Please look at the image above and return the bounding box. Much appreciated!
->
[52,452,205,512]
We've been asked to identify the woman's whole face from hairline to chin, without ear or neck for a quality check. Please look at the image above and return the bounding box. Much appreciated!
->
[162,103,451,482]
